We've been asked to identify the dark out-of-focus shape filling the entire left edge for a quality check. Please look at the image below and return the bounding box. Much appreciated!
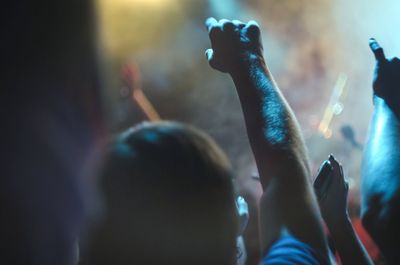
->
[0,0,103,265]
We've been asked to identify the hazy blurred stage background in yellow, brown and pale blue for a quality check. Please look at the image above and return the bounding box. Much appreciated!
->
[97,0,400,202]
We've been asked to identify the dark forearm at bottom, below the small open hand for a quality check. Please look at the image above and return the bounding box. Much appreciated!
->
[327,217,374,265]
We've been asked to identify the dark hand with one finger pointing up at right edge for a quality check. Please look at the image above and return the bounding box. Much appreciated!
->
[369,39,400,108]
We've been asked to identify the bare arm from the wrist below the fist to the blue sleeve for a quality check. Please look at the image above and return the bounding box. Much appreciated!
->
[231,54,326,254]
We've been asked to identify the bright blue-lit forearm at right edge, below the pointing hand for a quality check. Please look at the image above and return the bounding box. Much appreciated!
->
[361,97,400,260]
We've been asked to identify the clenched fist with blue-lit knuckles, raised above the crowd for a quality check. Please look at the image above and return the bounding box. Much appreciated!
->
[205,18,263,73]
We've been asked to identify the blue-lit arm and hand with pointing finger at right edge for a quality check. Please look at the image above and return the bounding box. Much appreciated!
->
[361,39,400,261]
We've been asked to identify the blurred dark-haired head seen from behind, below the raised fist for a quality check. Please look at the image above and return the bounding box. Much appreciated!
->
[85,122,237,264]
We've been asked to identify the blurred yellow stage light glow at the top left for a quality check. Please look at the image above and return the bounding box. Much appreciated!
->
[97,0,184,58]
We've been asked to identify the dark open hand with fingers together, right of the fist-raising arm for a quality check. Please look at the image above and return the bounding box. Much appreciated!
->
[314,155,349,227]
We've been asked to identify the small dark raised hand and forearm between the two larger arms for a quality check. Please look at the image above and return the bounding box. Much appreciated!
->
[314,155,373,265]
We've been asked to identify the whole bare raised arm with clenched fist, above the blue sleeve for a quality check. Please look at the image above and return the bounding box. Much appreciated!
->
[206,18,326,255]
